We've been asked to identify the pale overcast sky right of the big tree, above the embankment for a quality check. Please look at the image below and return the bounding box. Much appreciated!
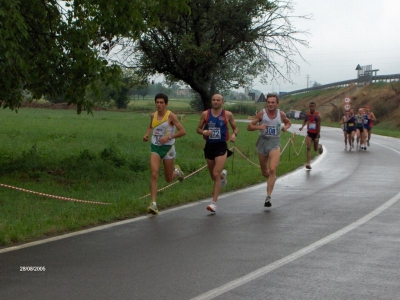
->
[253,0,400,93]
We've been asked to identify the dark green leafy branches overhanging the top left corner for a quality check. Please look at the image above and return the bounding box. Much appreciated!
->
[0,0,187,113]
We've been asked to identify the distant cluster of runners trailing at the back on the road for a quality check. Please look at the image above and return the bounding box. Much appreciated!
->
[340,106,376,151]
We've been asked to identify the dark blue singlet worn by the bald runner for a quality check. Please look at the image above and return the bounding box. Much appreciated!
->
[203,109,229,143]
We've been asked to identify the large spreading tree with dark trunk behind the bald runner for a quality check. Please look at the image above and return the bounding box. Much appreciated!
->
[123,0,308,108]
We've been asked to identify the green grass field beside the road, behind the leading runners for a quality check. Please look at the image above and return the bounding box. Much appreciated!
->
[0,108,312,246]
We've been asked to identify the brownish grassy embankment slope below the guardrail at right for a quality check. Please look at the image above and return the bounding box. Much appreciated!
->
[279,81,400,129]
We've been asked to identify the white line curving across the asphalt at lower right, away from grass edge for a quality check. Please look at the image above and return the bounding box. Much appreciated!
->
[191,193,400,300]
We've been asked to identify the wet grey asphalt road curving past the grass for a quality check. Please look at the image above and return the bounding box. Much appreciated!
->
[0,125,400,299]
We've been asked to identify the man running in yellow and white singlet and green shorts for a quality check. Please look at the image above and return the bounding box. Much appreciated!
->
[143,94,186,215]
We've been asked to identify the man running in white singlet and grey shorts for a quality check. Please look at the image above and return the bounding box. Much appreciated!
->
[247,94,291,207]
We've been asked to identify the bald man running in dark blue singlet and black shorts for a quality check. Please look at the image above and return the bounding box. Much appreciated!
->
[197,94,238,213]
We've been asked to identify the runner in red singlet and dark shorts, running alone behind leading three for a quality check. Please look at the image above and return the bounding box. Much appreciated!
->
[299,102,324,170]
